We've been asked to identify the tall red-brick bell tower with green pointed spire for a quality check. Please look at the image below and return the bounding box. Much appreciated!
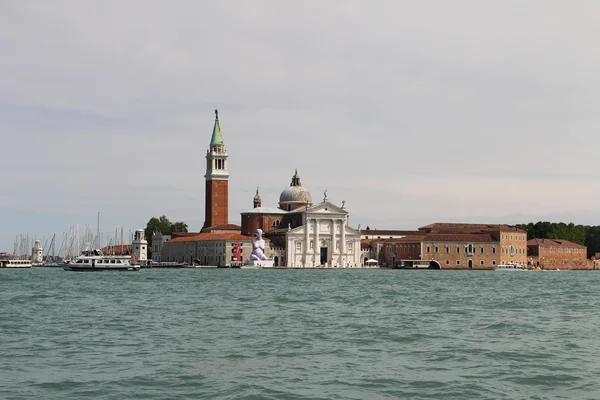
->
[202,110,229,229]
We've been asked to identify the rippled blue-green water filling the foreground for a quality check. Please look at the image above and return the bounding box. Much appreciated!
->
[0,268,600,400]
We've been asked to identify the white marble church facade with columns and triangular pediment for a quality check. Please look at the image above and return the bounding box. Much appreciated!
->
[286,201,362,268]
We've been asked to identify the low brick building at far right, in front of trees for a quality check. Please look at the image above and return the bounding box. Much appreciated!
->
[527,239,593,269]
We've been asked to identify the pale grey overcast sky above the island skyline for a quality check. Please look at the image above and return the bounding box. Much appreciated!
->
[0,0,600,251]
